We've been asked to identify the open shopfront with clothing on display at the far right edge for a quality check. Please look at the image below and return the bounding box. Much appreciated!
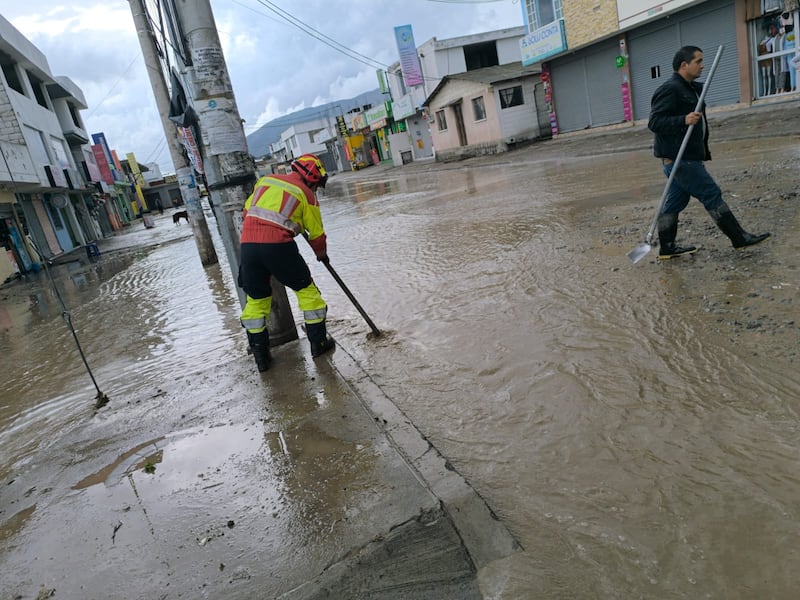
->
[747,0,800,99]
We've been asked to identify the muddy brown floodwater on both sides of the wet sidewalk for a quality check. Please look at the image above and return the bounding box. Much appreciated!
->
[0,130,800,599]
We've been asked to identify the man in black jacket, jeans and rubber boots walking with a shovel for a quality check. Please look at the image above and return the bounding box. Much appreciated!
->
[647,46,769,259]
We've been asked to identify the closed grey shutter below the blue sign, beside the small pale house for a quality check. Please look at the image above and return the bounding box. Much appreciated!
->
[550,40,625,133]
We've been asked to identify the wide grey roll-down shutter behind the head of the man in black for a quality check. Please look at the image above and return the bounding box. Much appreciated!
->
[628,0,740,119]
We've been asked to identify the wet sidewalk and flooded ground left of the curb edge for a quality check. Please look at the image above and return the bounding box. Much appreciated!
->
[0,209,517,599]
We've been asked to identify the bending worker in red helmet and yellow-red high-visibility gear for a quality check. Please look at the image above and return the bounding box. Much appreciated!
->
[239,154,336,371]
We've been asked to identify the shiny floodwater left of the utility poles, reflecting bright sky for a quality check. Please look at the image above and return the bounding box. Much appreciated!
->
[0,237,241,478]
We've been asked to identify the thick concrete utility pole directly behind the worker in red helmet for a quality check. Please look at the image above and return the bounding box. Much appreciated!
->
[172,0,298,346]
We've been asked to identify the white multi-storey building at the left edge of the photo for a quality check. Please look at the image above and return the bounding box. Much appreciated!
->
[0,11,119,281]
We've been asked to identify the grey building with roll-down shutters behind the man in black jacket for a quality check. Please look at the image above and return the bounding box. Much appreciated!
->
[521,0,800,133]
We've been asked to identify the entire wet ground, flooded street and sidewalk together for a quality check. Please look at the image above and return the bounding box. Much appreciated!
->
[0,103,800,600]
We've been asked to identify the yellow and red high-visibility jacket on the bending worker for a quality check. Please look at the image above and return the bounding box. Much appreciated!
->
[241,173,327,254]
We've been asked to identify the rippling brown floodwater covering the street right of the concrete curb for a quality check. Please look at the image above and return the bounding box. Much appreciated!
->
[323,140,800,598]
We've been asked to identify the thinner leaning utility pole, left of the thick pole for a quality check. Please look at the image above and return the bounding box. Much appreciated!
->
[128,0,219,267]
